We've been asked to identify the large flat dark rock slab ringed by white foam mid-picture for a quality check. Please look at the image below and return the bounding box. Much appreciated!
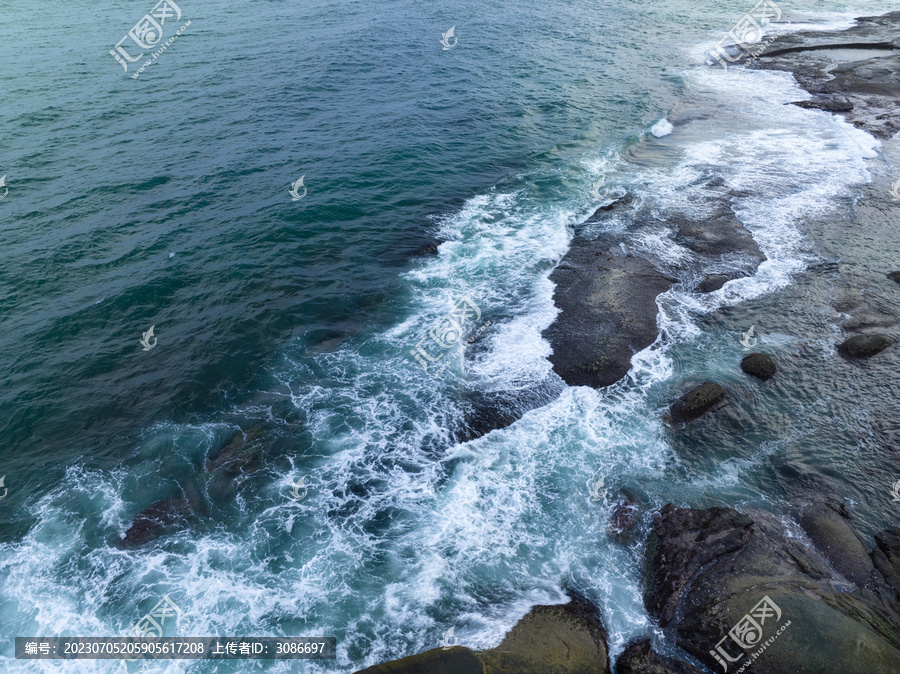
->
[544,239,673,387]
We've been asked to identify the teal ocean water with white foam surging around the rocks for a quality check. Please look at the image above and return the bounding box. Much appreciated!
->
[0,0,900,672]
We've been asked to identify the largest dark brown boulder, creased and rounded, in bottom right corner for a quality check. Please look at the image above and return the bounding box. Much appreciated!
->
[644,505,900,674]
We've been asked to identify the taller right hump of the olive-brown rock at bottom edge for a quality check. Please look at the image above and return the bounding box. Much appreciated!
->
[478,596,610,674]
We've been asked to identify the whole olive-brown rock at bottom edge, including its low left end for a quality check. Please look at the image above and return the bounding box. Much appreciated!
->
[356,596,610,674]
